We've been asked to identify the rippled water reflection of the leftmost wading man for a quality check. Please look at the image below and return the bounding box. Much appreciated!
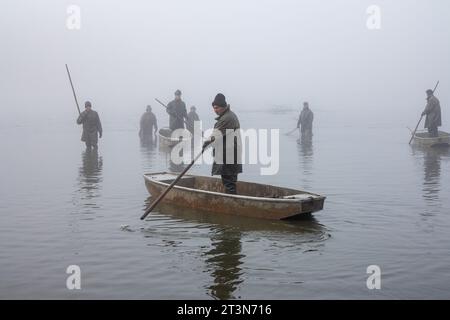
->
[77,150,103,213]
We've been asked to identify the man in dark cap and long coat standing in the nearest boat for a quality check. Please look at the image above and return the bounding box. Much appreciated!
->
[203,93,242,194]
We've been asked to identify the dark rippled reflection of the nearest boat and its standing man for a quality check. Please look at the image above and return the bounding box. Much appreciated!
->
[144,197,330,299]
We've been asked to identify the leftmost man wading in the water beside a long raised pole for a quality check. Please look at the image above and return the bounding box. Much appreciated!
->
[77,101,103,151]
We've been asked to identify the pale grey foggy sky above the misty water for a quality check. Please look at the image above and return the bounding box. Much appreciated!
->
[0,0,450,131]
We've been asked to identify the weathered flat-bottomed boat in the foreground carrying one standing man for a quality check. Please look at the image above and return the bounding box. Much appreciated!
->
[144,172,325,219]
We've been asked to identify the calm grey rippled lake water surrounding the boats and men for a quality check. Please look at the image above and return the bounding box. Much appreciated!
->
[0,110,450,299]
